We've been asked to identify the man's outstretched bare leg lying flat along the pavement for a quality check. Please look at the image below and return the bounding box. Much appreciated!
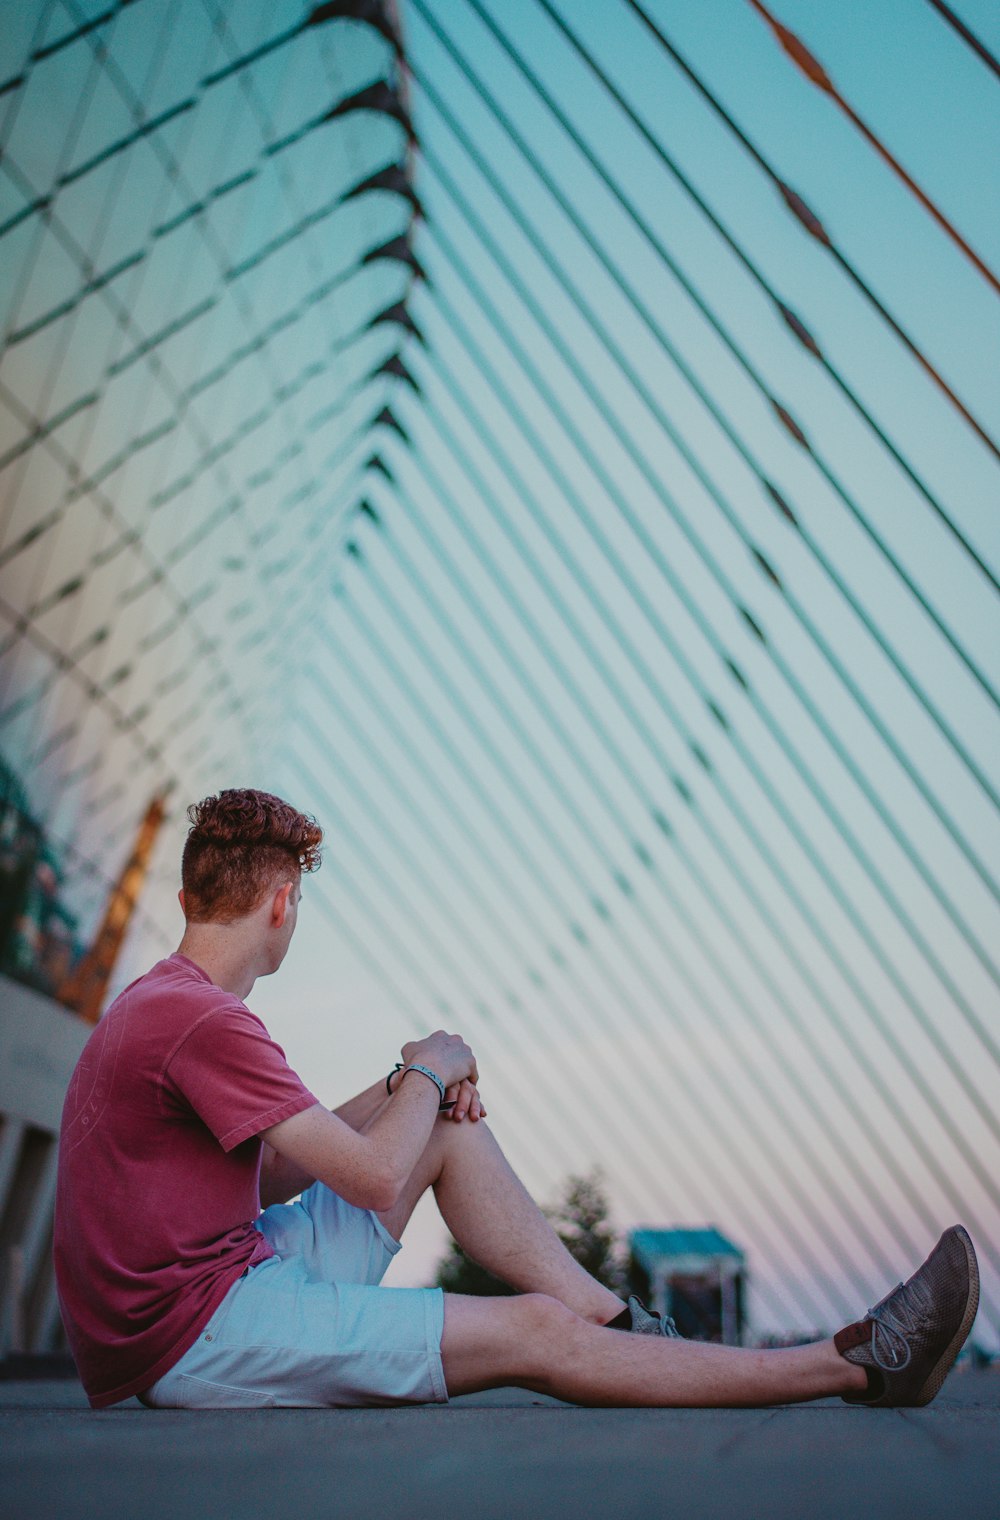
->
[441,1294,868,1408]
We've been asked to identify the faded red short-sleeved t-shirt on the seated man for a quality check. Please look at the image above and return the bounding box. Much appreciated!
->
[55,955,316,1409]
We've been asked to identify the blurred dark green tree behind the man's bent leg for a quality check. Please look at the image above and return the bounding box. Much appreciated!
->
[435,1170,623,1298]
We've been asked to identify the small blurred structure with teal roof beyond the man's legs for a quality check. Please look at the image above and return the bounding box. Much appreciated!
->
[629,1225,746,1345]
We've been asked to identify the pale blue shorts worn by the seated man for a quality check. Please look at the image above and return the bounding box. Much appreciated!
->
[141,1183,448,1409]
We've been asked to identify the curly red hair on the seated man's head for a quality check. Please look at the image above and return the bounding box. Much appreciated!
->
[181,787,322,924]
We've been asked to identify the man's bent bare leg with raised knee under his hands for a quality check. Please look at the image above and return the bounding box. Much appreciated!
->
[378,1119,625,1325]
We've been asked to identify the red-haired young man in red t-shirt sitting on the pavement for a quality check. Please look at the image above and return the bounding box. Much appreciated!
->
[55,790,979,1409]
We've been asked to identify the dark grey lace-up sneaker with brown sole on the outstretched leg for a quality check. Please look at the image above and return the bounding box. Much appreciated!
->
[833,1225,979,1409]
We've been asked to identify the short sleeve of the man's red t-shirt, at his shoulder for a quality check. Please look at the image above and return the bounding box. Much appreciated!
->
[164,1005,318,1151]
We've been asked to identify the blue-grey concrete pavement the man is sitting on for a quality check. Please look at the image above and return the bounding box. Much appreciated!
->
[0,1371,1000,1520]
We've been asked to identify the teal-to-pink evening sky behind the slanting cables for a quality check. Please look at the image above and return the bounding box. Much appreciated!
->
[0,0,1000,1341]
